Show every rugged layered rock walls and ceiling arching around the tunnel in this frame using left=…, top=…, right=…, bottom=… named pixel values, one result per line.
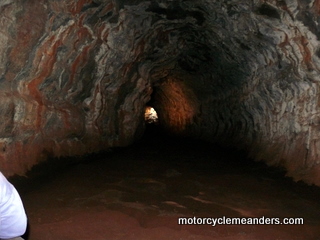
left=0, top=0, right=320, bottom=185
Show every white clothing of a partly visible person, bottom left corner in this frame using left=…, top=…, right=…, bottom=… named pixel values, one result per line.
left=0, top=172, right=27, bottom=239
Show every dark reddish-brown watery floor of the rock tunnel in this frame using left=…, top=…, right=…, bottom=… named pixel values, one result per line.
left=11, top=129, right=320, bottom=240
